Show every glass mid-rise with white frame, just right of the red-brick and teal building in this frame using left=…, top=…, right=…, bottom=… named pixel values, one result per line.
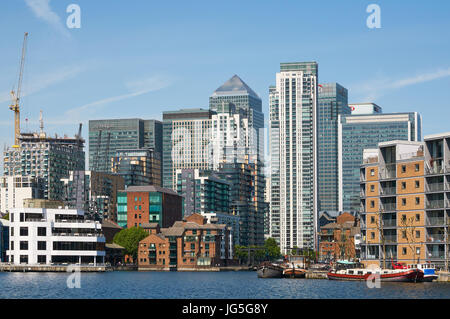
left=176, top=169, right=230, bottom=216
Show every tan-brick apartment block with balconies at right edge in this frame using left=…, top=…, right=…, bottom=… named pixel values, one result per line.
left=361, top=133, right=450, bottom=267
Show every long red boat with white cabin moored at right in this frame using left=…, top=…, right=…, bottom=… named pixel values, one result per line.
left=327, top=268, right=423, bottom=282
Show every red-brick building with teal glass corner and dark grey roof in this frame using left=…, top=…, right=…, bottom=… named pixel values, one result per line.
left=117, top=185, right=183, bottom=228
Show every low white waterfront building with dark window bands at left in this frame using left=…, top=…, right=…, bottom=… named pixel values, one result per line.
left=7, top=208, right=105, bottom=265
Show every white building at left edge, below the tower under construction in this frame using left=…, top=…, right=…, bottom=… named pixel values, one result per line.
left=0, top=175, right=43, bottom=213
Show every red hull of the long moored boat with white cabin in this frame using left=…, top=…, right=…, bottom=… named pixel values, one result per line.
left=327, top=269, right=424, bottom=282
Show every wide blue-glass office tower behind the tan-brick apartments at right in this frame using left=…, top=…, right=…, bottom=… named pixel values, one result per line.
left=338, top=112, right=422, bottom=211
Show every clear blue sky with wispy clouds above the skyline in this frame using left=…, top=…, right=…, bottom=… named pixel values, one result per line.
left=0, top=0, right=450, bottom=155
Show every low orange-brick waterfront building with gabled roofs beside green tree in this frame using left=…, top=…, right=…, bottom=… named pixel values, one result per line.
left=138, top=214, right=233, bottom=271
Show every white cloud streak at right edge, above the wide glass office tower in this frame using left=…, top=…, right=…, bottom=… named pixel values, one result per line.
left=349, top=68, right=450, bottom=101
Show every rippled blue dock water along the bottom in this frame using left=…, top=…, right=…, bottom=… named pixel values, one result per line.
left=0, top=271, right=450, bottom=299
